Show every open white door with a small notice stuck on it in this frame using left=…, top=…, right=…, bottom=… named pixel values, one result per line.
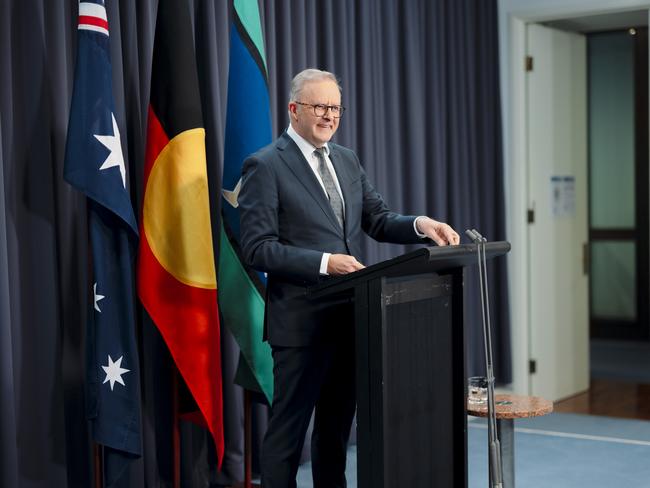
left=526, top=24, right=589, bottom=401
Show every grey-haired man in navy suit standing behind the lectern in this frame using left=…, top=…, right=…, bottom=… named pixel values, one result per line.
left=238, top=69, right=459, bottom=488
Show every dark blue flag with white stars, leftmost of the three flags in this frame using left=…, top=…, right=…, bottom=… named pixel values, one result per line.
left=64, top=0, right=142, bottom=486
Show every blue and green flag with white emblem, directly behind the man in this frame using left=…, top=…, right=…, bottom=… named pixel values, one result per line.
left=219, top=0, right=273, bottom=405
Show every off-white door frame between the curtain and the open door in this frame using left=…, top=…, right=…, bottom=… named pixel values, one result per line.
left=499, top=4, right=650, bottom=394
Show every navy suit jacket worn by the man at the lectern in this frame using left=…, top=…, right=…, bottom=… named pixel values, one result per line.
left=238, top=132, right=424, bottom=346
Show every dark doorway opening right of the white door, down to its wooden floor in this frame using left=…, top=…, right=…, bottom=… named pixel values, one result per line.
left=587, top=25, right=650, bottom=418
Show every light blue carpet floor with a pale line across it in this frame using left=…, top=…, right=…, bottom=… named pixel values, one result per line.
left=298, top=413, right=650, bottom=488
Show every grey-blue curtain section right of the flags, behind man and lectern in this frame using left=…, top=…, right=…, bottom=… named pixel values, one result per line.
left=264, top=0, right=512, bottom=383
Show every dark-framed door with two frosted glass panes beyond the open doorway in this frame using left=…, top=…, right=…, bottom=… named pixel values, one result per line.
left=587, top=25, right=650, bottom=341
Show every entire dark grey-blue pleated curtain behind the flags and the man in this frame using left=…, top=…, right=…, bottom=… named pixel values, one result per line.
left=0, top=0, right=511, bottom=487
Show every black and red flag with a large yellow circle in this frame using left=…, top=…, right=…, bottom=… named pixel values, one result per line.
left=138, top=0, right=224, bottom=465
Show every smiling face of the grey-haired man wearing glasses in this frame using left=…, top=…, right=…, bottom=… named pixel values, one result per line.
left=289, top=80, right=341, bottom=147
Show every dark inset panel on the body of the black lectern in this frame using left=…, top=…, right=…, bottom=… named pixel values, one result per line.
left=381, top=275, right=450, bottom=487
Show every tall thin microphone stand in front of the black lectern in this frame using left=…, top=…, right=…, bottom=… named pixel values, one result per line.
left=465, top=229, right=503, bottom=488
